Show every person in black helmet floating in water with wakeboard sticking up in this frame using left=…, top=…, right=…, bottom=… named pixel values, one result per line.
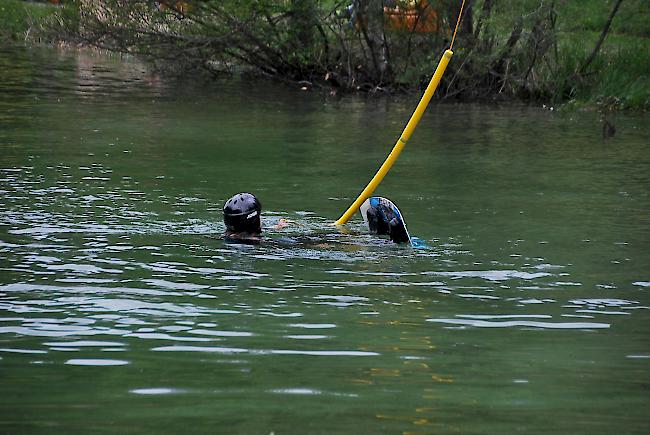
left=223, top=193, right=410, bottom=244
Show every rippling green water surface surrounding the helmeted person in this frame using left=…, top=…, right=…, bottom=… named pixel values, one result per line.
left=0, top=49, right=650, bottom=434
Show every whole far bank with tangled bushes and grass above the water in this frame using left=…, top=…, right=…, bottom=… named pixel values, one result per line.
left=0, top=0, right=650, bottom=111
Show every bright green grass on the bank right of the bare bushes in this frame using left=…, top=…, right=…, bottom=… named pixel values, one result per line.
left=473, top=0, right=650, bottom=111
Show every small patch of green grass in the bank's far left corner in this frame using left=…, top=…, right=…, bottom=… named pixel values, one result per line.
left=0, top=0, right=58, bottom=42
